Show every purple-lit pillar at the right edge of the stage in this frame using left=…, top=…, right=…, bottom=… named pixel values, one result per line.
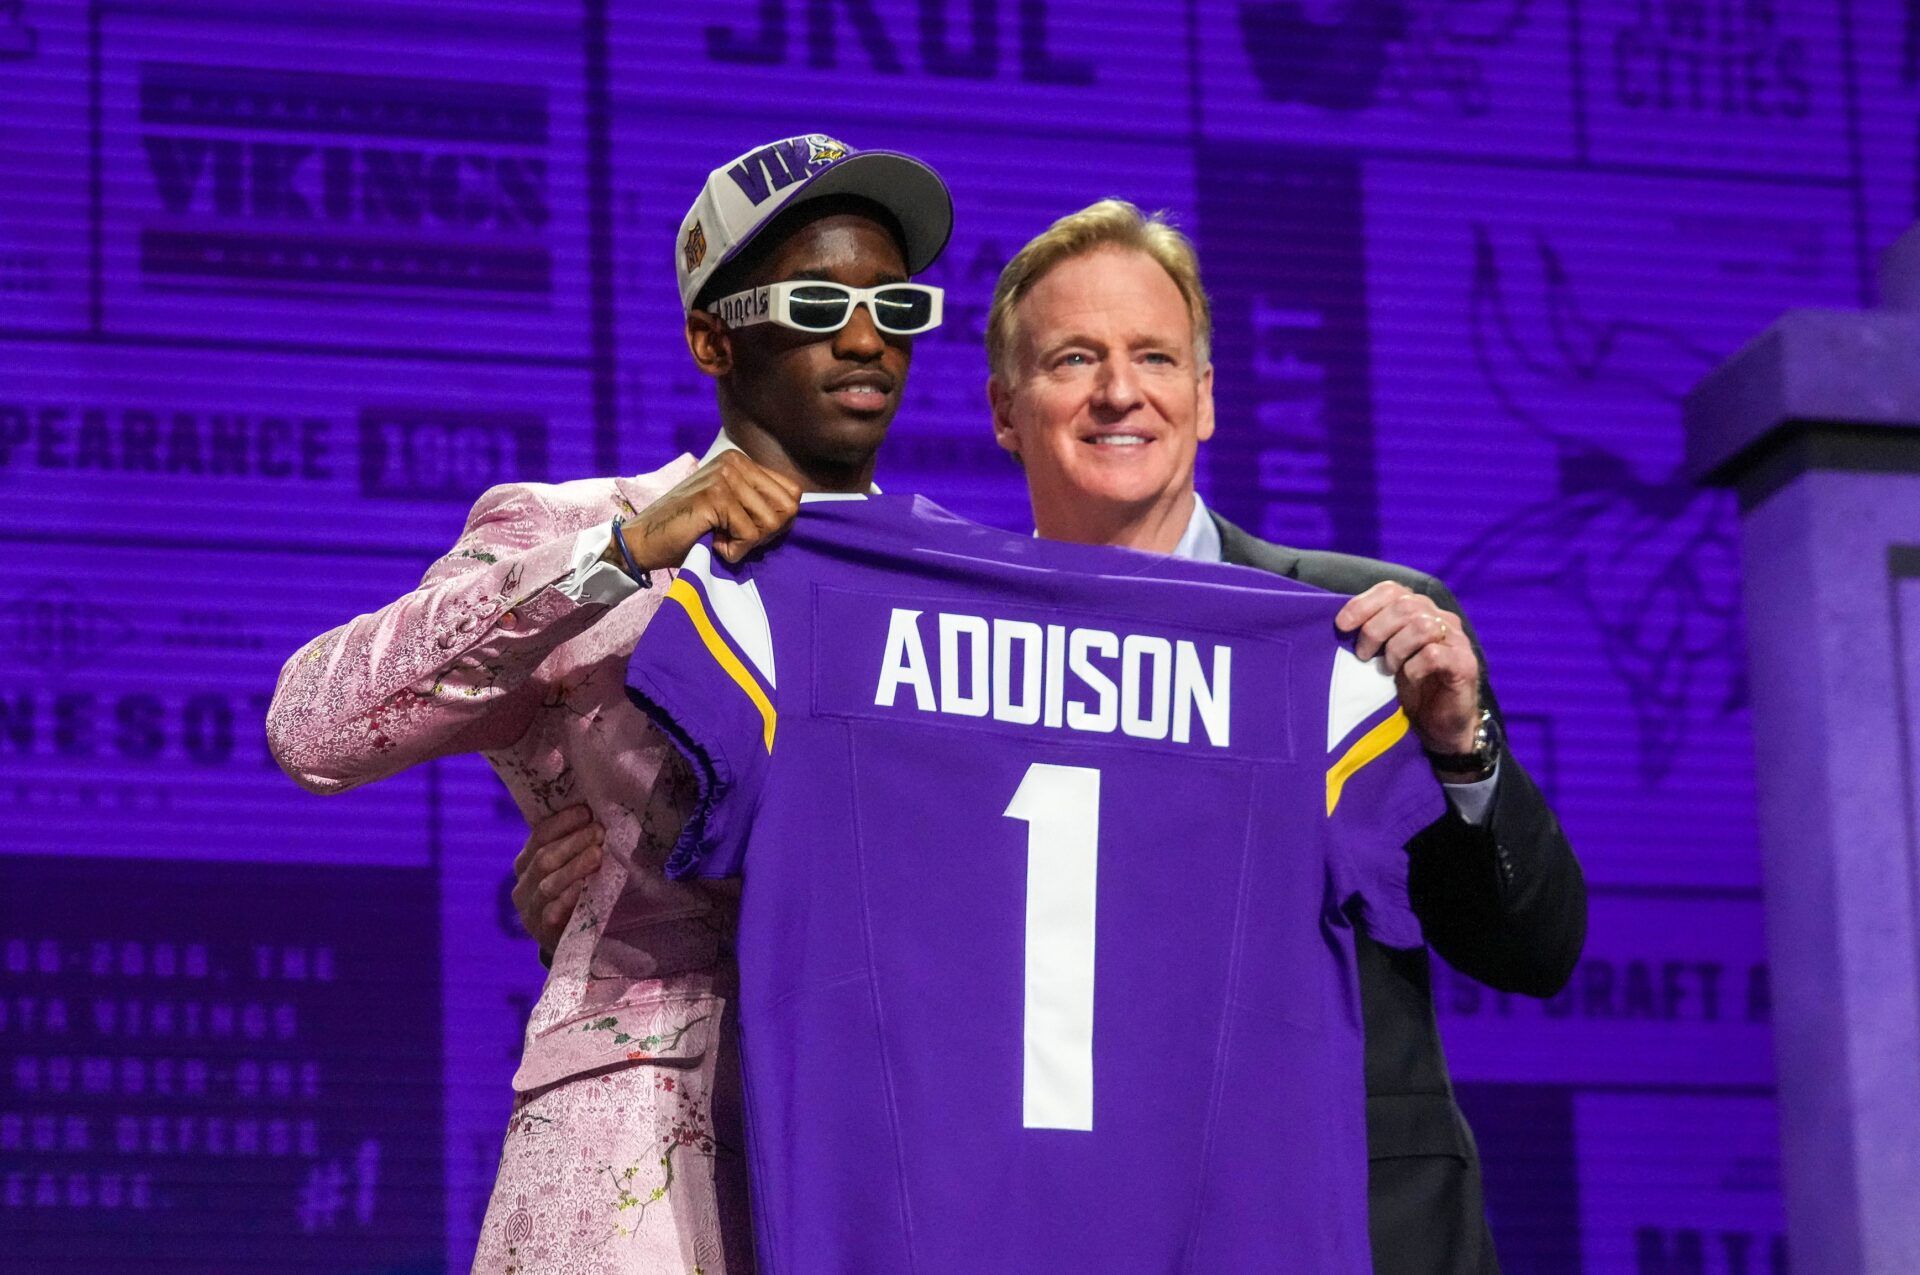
left=1686, top=225, right=1920, bottom=1275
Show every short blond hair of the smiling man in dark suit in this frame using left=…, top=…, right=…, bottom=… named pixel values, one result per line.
left=987, top=200, right=1213, bottom=384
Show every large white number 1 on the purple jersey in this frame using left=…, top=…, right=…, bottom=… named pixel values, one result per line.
left=1006, top=762, right=1100, bottom=1129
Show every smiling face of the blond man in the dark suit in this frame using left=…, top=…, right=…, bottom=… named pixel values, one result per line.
left=989, top=248, right=1213, bottom=553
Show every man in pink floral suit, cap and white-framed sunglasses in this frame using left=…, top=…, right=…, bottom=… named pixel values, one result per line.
left=267, top=134, right=952, bottom=1275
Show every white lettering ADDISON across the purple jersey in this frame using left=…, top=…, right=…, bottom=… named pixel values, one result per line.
left=874, top=607, right=1233, bottom=749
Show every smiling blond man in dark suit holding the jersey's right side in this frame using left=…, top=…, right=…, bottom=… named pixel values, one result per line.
left=516, top=200, right=1586, bottom=1275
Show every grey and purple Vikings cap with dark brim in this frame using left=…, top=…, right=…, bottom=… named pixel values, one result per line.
left=674, top=132, right=954, bottom=309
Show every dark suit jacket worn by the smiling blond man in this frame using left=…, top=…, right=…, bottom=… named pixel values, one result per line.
left=1213, top=515, right=1586, bottom=1275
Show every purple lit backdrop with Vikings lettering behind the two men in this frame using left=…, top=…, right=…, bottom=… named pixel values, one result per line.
left=0, top=0, right=1920, bottom=1275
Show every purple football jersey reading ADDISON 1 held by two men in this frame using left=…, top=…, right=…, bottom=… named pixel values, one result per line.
left=628, top=495, right=1444, bottom=1275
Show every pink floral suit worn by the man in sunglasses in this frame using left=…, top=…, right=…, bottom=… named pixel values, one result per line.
left=267, top=455, right=751, bottom=1275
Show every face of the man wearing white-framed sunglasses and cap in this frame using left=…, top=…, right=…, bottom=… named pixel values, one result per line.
left=687, top=211, right=914, bottom=492
